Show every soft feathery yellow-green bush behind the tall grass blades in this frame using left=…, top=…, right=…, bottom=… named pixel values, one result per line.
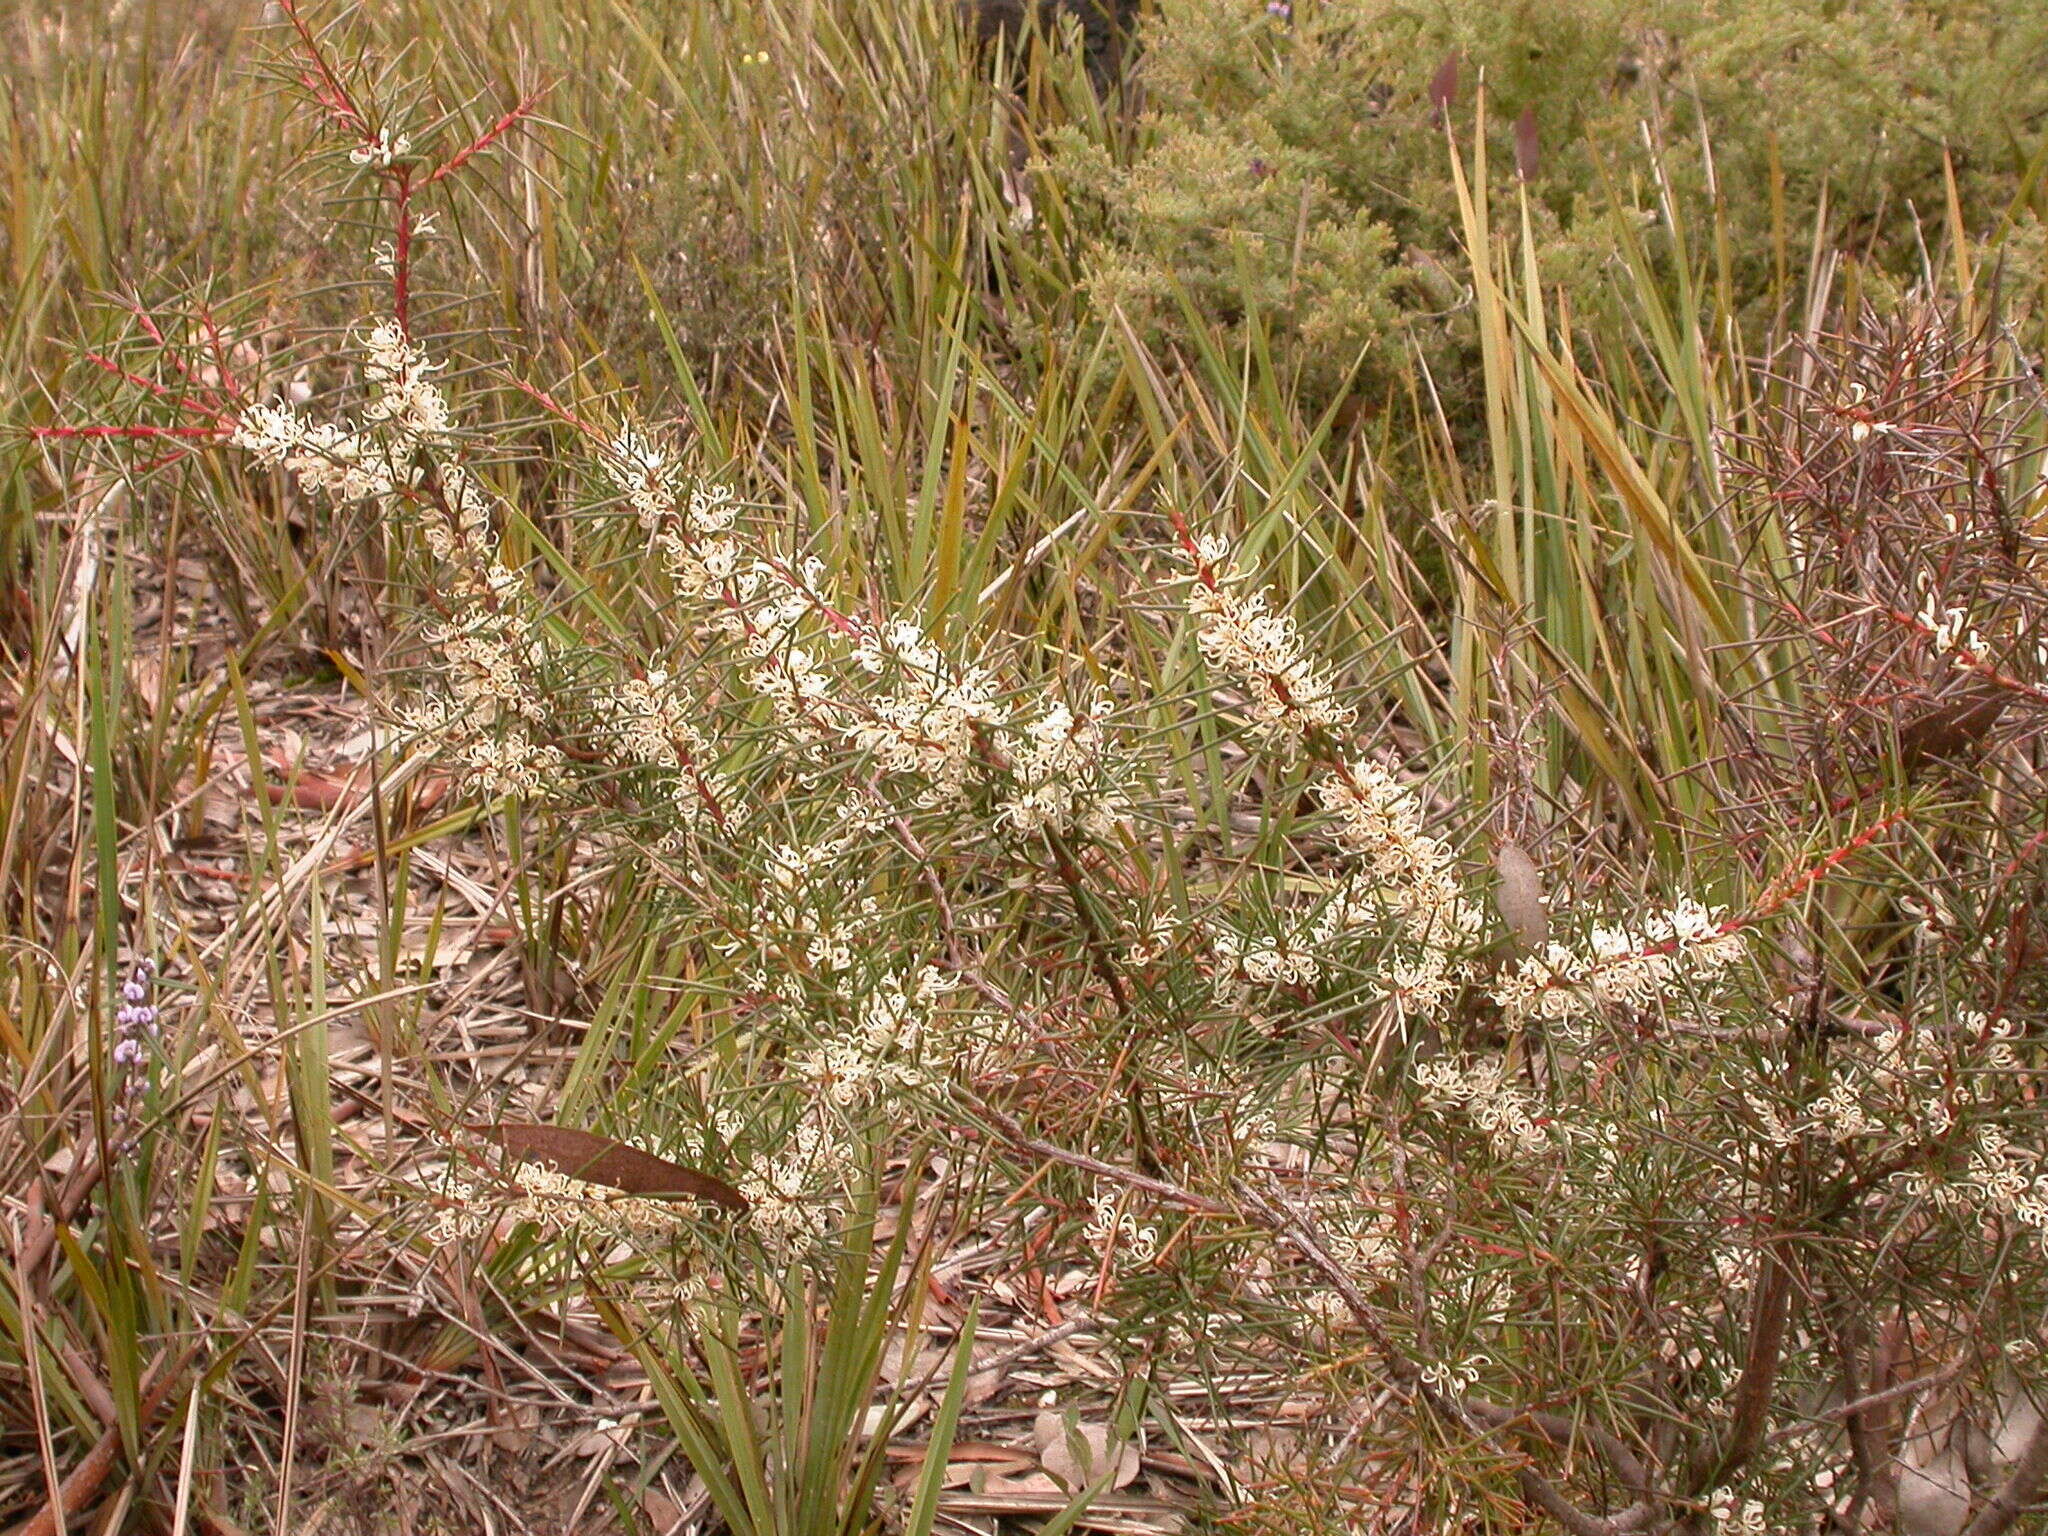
left=1049, top=0, right=2048, bottom=395
